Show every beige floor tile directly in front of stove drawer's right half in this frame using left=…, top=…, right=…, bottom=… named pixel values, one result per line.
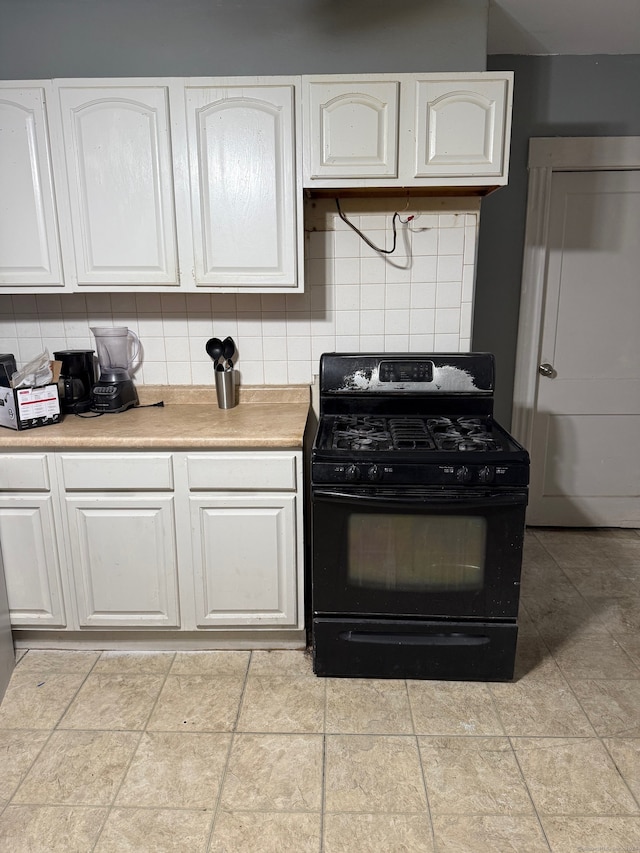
left=407, top=681, right=504, bottom=735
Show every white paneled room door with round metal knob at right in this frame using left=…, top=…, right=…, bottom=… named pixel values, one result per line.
left=516, top=162, right=640, bottom=527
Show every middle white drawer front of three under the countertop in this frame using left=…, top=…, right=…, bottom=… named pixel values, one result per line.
left=60, top=452, right=173, bottom=492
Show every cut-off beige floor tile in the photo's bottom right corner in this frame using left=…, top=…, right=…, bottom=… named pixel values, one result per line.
left=542, top=817, right=640, bottom=853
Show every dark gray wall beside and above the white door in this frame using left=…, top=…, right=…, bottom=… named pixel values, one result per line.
left=473, top=55, right=640, bottom=425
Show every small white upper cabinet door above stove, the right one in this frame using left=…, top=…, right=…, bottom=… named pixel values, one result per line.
left=410, top=79, right=510, bottom=185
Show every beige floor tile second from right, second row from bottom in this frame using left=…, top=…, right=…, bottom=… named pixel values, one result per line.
left=512, top=738, right=639, bottom=815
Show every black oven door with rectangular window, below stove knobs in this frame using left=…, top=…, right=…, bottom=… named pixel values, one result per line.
left=312, top=487, right=527, bottom=620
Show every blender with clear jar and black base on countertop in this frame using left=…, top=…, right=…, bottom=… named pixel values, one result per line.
left=91, top=326, right=140, bottom=413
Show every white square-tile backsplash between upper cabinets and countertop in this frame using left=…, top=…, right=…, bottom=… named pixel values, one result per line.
left=0, top=198, right=480, bottom=384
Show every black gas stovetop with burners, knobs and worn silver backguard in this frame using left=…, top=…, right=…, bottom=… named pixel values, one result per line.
left=311, top=353, right=529, bottom=486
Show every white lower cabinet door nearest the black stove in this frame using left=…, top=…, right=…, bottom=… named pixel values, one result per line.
left=190, top=494, right=297, bottom=628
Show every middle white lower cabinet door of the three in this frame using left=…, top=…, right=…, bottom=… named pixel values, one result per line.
left=65, top=494, right=179, bottom=628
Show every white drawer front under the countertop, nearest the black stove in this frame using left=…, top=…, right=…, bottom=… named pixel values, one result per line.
left=187, top=452, right=296, bottom=491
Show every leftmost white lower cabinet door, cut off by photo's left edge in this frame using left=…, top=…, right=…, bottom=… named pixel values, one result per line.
left=0, top=493, right=66, bottom=628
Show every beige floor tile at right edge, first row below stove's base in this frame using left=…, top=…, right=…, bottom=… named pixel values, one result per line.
left=573, top=679, right=640, bottom=737
